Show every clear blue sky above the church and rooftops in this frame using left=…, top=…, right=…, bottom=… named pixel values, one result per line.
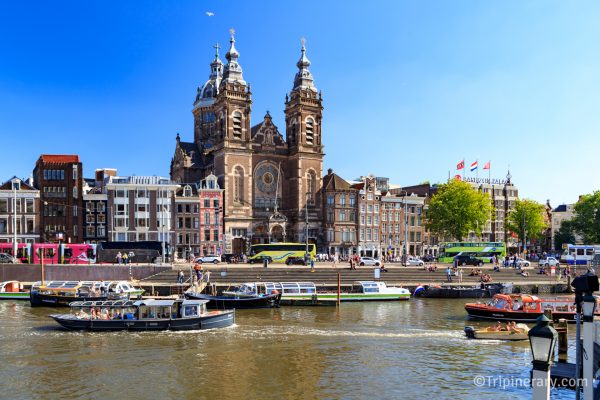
left=0, top=0, right=600, bottom=205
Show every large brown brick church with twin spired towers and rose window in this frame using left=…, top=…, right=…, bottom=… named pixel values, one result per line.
left=171, top=30, right=324, bottom=253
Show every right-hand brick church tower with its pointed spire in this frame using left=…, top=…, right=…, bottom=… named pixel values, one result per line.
left=285, top=39, right=323, bottom=243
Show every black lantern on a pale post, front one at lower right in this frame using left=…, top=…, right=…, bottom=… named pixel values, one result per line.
left=528, top=315, right=558, bottom=400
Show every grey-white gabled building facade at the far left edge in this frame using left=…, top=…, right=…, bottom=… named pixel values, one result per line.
left=0, top=177, right=40, bottom=243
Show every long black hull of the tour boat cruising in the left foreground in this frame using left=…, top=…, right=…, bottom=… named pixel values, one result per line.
left=50, top=310, right=235, bottom=332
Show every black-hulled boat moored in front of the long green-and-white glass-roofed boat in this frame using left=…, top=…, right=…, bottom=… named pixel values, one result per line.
left=185, top=283, right=281, bottom=309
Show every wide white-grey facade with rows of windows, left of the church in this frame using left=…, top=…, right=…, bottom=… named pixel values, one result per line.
left=104, top=176, right=179, bottom=247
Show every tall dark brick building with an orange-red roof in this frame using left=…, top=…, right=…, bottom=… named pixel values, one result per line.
left=33, top=154, right=83, bottom=243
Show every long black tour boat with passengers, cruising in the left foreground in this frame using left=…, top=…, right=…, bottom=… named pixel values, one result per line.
left=50, top=299, right=235, bottom=331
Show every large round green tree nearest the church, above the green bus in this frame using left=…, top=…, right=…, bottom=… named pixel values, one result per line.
left=425, top=181, right=493, bottom=241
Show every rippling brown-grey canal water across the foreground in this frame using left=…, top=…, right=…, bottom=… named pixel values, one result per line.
left=0, top=299, right=574, bottom=399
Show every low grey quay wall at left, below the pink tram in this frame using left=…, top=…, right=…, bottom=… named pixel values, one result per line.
left=0, top=264, right=171, bottom=283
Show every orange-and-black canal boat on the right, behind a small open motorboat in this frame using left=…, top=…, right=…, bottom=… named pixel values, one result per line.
left=465, top=294, right=600, bottom=322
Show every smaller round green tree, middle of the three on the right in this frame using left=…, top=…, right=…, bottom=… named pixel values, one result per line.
left=506, top=199, right=548, bottom=252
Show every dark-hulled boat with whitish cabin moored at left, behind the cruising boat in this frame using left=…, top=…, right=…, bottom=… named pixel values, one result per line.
left=29, top=281, right=108, bottom=307
